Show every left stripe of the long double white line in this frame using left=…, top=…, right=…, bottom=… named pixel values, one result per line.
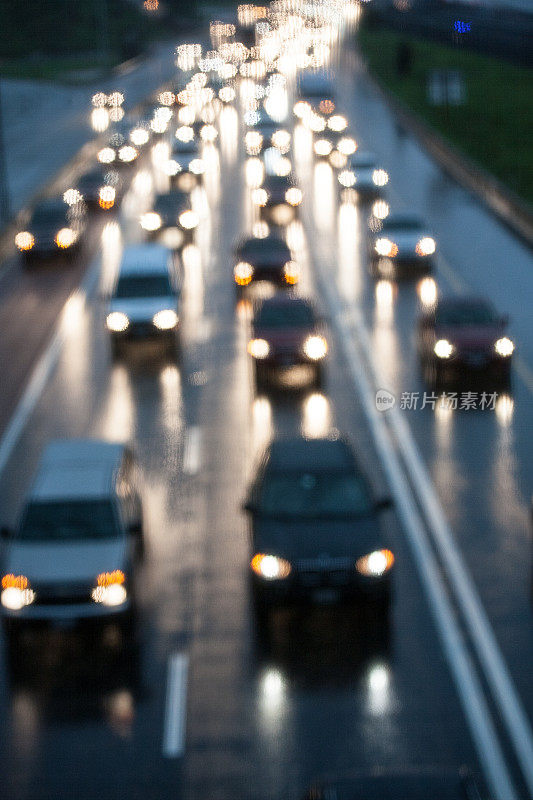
left=310, top=268, right=518, bottom=800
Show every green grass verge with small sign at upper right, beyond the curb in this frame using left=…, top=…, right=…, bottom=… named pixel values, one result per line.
left=358, top=25, right=533, bottom=209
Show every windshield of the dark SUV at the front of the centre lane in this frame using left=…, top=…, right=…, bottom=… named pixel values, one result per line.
left=259, top=472, right=371, bottom=519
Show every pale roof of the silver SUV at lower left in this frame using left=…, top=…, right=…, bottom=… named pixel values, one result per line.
left=30, top=439, right=124, bottom=502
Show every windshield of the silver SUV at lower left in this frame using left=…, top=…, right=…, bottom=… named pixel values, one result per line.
left=19, top=500, right=120, bottom=542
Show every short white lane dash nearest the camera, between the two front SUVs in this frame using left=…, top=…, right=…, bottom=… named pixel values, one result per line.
left=163, top=653, right=189, bottom=758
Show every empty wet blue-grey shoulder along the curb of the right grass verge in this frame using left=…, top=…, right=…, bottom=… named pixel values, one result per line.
left=338, top=42, right=533, bottom=369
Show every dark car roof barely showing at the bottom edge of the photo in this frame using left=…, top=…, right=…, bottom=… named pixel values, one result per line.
left=304, top=768, right=488, bottom=800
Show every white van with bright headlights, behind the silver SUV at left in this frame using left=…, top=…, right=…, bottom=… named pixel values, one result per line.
left=106, top=243, right=181, bottom=354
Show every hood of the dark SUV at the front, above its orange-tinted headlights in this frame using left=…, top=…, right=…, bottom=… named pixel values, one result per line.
left=254, top=517, right=383, bottom=562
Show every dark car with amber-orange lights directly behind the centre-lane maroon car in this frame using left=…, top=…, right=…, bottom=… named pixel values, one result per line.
left=233, top=234, right=300, bottom=295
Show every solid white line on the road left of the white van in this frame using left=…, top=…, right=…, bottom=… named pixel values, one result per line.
left=0, top=259, right=98, bottom=474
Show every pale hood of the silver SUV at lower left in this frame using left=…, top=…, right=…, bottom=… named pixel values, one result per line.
left=4, top=537, right=128, bottom=585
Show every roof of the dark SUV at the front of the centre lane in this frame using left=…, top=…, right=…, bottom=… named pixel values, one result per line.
left=268, top=436, right=356, bottom=472
